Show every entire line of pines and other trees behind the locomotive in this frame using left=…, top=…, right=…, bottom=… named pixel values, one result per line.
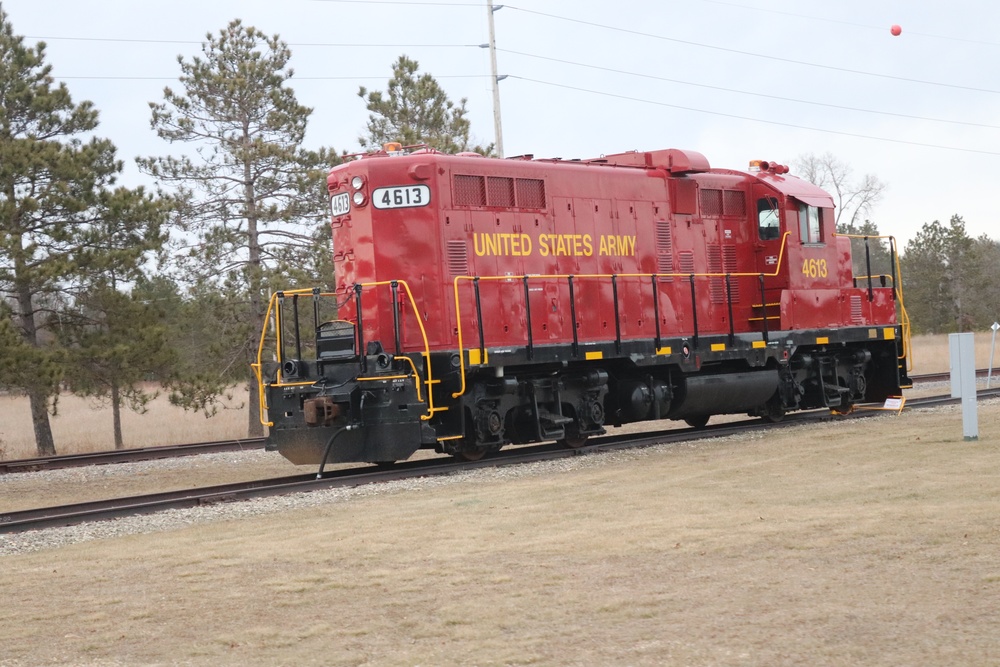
left=0, top=8, right=998, bottom=456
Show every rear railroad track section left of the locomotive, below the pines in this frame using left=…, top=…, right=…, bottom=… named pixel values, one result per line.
left=0, top=438, right=264, bottom=475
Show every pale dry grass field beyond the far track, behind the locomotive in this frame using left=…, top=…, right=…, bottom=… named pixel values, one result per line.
left=0, top=332, right=1000, bottom=459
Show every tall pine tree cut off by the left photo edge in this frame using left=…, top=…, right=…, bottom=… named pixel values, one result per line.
left=0, top=9, right=137, bottom=456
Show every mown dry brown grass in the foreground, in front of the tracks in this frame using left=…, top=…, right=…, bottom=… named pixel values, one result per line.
left=0, top=402, right=1000, bottom=666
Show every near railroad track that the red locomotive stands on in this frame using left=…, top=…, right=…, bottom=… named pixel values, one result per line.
left=0, top=388, right=1000, bottom=534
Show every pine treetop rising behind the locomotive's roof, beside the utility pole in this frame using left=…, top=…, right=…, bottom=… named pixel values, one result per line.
left=358, top=55, right=493, bottom=155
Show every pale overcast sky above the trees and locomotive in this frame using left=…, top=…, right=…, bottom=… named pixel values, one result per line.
left=0, top=0, right=1000, bottom=244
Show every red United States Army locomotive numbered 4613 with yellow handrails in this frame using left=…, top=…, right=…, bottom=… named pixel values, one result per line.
left=255, top=146, right=909, bottom=466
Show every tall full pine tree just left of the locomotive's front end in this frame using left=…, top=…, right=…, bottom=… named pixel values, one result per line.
left=139, top=20, right=338, bottom=435
